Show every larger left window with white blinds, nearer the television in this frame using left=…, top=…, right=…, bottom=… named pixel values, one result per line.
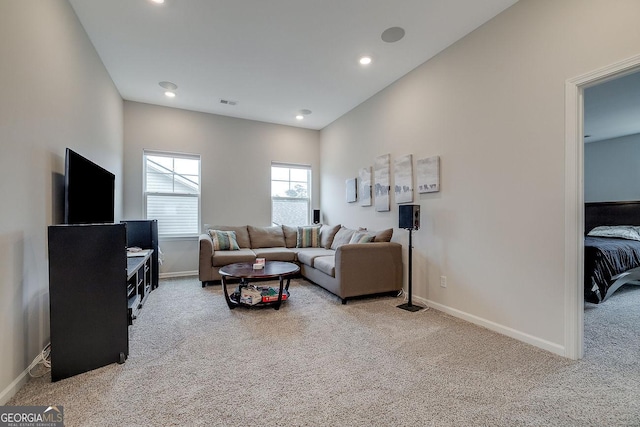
left=144, top=151, right=200, bottom=237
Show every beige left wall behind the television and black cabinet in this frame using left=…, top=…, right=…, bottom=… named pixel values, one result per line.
left=0, top=0, right=123, bottom=404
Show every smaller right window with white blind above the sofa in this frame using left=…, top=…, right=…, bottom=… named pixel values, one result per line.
left=271, top=162, right=311, bottom=226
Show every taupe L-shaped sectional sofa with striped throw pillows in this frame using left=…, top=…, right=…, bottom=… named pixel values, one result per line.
left=199, top=224, right=403, bottom=304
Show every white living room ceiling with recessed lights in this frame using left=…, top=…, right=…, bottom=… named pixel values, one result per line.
left=70, top=0, right=516, bottom=129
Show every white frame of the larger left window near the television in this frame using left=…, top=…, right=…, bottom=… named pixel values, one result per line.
left=142, top=149, right=202, bottom=240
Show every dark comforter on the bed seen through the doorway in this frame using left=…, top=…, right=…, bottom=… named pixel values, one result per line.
left=584, top=236, right=640, bottom=304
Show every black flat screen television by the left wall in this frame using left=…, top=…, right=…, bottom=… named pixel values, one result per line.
left=64, top=148, right=116, bottom=224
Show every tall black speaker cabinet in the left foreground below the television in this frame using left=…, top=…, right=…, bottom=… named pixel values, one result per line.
left=49, top=224, right=129, bottom=381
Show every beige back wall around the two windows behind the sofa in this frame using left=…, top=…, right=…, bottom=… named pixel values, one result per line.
left=124, top=101, right=320, bottom=274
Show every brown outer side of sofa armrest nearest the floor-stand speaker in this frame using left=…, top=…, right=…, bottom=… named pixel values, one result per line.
left=335, top=242, right=403, bottom=298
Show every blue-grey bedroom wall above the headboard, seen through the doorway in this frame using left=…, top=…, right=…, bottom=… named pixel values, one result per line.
left=584, top=134, right=640, bottom=202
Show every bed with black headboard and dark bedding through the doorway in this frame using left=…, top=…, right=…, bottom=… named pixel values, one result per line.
left=584, top=201, right=640, bottom=304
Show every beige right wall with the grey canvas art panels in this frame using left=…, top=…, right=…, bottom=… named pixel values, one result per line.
left=321, top=0, right=640, bottom=354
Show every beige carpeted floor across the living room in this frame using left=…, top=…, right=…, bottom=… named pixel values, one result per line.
left=8, top=278, right=640, bottom=427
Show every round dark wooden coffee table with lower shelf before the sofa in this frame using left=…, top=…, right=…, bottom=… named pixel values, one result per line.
left=219, top=261, right=300, bottom=310
